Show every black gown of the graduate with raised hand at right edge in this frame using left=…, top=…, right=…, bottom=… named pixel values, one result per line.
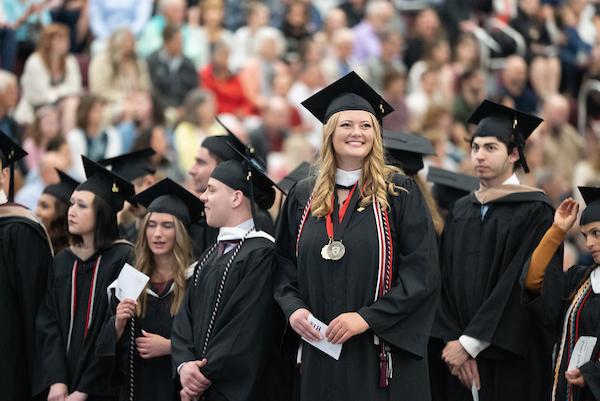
left=523, top=263, right=600, bottom=401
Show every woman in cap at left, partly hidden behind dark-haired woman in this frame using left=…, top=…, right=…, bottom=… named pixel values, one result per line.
left=35, top=169, right=80, bottom=254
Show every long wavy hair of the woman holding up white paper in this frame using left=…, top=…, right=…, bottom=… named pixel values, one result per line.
left=135, top=212, right=192, bottom=316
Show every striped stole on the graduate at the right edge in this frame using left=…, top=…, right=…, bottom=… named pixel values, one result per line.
left=552, top=277, right=592, bottom=401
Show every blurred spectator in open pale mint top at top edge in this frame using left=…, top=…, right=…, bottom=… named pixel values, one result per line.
left=137, top=0, right=209, bottom=68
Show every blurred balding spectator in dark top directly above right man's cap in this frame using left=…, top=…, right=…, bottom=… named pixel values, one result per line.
left=499, top=55, right=537, bottom=114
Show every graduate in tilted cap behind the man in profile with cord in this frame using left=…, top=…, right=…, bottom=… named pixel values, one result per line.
left=188, top=126, right=275, bottom=258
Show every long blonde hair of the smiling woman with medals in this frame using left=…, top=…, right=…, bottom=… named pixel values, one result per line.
left=311, top=112, right=400, bottom=217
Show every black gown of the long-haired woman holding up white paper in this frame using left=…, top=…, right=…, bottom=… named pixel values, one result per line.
left=97, top=287, right=179, bottom=401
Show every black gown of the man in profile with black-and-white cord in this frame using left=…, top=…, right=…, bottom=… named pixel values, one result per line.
left=171, top=238, right=286, bottom=401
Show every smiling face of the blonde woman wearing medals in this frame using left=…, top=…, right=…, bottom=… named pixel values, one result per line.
left=332, top=110, right=375, bottom=170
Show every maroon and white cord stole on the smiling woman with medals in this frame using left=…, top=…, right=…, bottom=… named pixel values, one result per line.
left=296, top=194, right=393, bottom=388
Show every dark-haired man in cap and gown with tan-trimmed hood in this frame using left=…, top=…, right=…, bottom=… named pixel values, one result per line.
left=432, top=100, right=561, bottom=401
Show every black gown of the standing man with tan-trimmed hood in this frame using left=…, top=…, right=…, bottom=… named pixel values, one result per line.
left=432, top=192, right=562, bottom=401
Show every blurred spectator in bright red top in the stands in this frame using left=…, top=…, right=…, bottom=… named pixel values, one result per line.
left=200, top=42, right=255, bottom=120
